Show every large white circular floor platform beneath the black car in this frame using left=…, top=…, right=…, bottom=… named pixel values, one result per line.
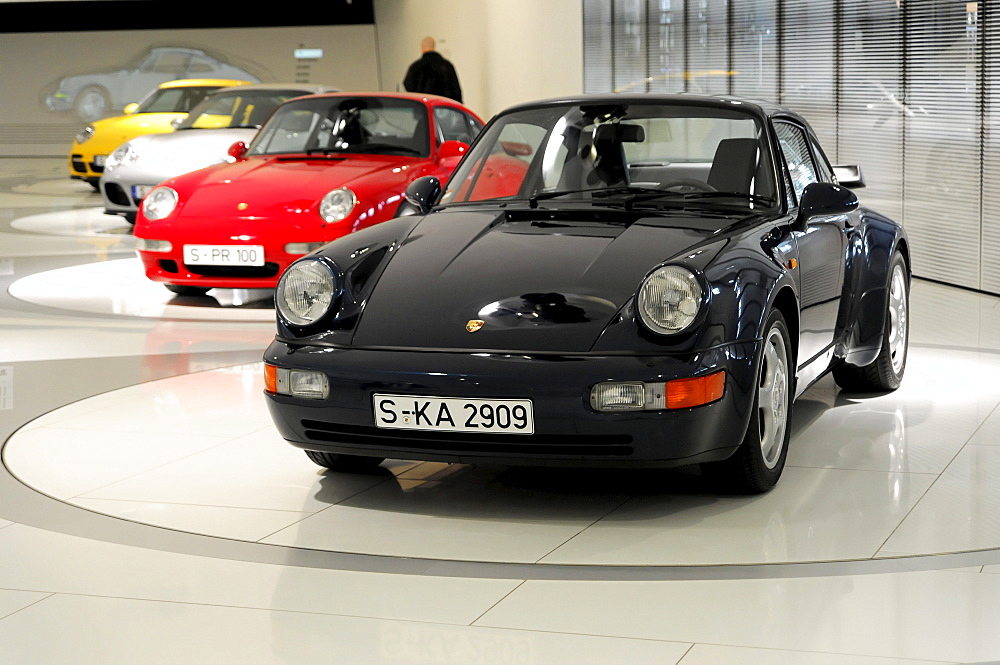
left=4, top=345, right=1000, bottom=566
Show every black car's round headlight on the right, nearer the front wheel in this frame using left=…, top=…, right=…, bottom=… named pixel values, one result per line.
left=638, top=266, right=703, bottom=335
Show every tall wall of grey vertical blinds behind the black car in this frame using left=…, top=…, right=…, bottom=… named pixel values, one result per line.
left=583, top=0, right=1000, bottom=293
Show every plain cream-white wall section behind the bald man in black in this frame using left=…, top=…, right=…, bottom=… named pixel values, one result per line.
left=374, top=0, right=583, bottom=119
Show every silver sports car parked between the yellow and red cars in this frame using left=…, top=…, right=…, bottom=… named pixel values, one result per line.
left=100, top=83, right=336, bottom=224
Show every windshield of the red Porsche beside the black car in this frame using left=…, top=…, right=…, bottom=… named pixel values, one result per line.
left=249, top=97, right=430, bottom=157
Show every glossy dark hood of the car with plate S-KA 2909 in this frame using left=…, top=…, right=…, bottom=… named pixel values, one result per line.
left=353, top=210, right=739, bottom=353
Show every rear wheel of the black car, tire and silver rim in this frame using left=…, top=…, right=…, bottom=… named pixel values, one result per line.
left=833, top=252, right=910, bottom=392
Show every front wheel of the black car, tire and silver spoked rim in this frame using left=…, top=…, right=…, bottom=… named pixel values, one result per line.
left=721, top=310, right=795, bottom=494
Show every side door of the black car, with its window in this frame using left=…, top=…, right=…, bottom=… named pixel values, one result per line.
left=774, top=120, right=848, bottom=371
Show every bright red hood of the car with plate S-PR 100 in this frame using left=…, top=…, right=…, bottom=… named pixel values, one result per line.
left=178, top=156, right=407, bottom=220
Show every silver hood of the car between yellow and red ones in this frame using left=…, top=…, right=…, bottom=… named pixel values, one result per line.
left=125, top=129, right=257, bottom=182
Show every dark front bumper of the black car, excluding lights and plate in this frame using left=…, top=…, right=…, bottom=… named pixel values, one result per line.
left=264, top=341, right=760, bottom=467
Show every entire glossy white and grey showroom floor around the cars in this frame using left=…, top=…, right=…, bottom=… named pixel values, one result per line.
left=0, top=159, right=1000, bottom=665
